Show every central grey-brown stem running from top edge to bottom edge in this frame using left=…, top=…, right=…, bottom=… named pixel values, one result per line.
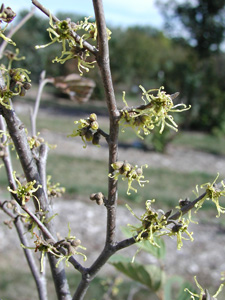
left=73, top=0, right=120, bottom=300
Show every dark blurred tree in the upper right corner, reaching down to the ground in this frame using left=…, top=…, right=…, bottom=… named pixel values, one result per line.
left=158, top=0, right=225, bottom=132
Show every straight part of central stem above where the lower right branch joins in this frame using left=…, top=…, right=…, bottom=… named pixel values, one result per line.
left=93, top=0, right=119, bottom=245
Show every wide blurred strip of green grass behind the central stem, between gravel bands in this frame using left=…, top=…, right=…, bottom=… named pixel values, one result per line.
left=44, top=154, right=214, bottom=207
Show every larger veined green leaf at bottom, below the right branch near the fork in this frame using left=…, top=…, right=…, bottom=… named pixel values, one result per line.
left=109, top=255, right=165, bottom=291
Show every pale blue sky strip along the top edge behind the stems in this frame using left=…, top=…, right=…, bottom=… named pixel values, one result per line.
left=5, top=0, right=163, bottom=29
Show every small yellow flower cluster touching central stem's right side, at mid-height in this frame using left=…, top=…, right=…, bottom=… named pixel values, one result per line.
left=109, top=161, right=149, bottom=195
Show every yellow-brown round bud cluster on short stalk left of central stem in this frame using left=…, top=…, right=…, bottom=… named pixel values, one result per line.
left=68, top=113, right=101, bottom=148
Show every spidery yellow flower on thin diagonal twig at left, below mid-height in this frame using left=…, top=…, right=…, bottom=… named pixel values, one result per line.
left=8, top=172, right=42, bottom=210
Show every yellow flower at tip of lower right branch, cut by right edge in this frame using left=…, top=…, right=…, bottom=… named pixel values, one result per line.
left=194, top=173, right=225, bottom=218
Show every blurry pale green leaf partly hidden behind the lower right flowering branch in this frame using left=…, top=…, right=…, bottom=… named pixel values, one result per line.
left=121, top=226, right=166, bottom=259
